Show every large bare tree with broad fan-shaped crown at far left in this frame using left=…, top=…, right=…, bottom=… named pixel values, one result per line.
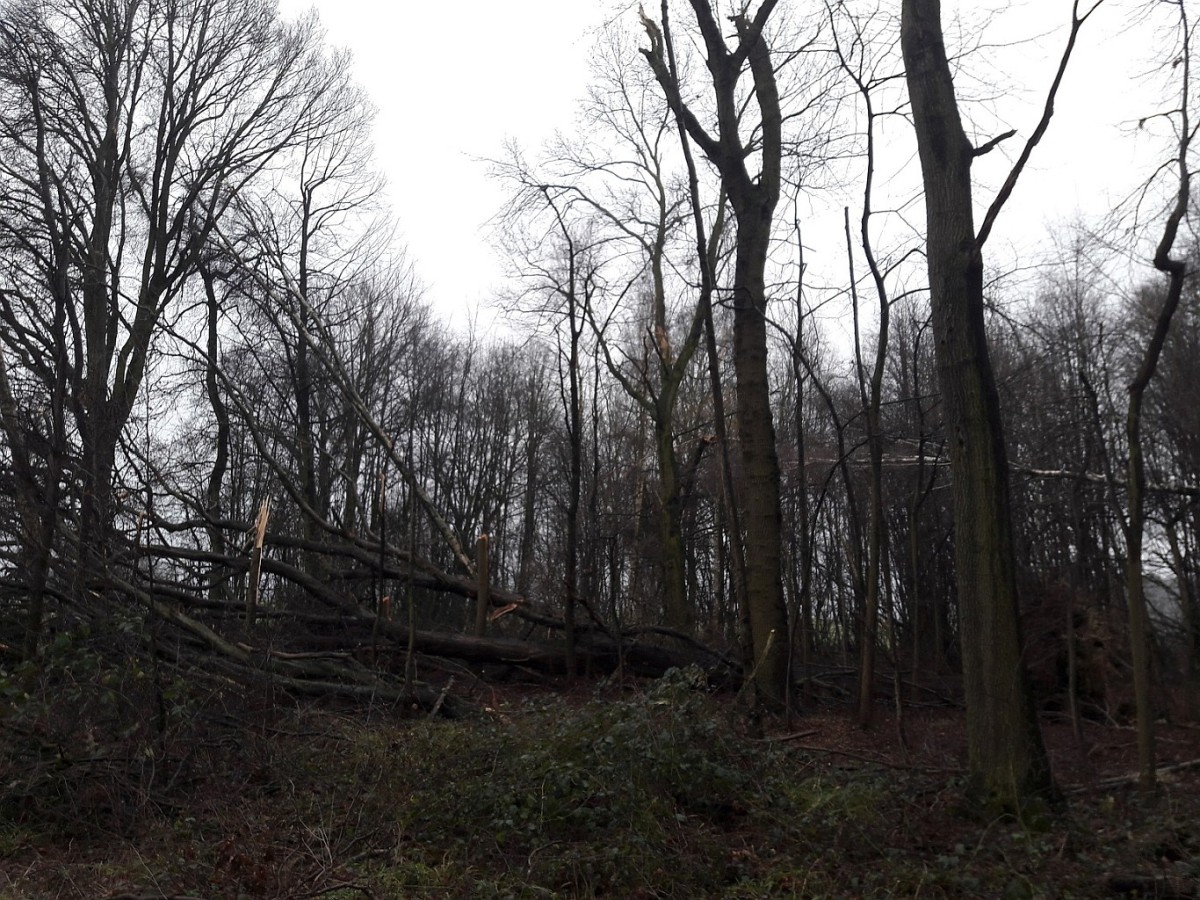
left=0, top=0, right=343, bottom=648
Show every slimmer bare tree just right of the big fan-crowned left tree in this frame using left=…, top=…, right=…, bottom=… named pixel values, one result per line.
left=221, top=66, right=388, bottom=578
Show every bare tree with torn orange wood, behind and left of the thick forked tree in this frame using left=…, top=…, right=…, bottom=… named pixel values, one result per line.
left=535, top=30, right=721, bottom=632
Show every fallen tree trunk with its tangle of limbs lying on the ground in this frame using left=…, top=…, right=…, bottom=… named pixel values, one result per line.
left=44, top=513, right=740, bottom=712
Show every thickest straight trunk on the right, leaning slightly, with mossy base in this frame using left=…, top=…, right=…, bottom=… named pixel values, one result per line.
left=901, top=0, right=1054, bottom=809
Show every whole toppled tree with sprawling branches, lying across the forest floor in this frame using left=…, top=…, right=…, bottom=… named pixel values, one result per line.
left=23, top=521, right=740, bottom=715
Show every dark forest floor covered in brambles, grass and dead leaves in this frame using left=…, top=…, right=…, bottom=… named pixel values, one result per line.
left=0, top=673, right=1200, bottom=900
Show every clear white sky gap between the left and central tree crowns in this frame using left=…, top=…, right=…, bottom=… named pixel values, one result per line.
left=273, top=0, right=609, bottom=325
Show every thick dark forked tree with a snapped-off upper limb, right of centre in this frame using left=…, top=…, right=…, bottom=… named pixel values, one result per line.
left=642, top=0, right=790, bottom=706
